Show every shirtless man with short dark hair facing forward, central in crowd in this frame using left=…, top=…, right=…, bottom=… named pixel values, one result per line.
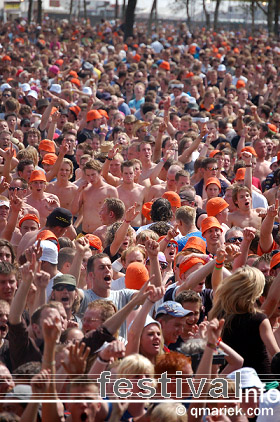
left=117, top=161, right=145, bottom=227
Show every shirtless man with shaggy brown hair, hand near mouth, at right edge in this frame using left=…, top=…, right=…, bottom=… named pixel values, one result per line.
left=228, top=186, right=262, bottom=230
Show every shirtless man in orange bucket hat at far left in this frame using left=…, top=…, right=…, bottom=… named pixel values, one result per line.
left=26, top=170, right=60, bottom=226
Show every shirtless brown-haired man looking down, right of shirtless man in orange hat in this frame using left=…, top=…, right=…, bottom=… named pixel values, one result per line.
left=71, top=160, right=118, bottom=234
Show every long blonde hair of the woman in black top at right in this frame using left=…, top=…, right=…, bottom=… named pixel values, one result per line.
left=209, top=265, right=265, bottom=320
